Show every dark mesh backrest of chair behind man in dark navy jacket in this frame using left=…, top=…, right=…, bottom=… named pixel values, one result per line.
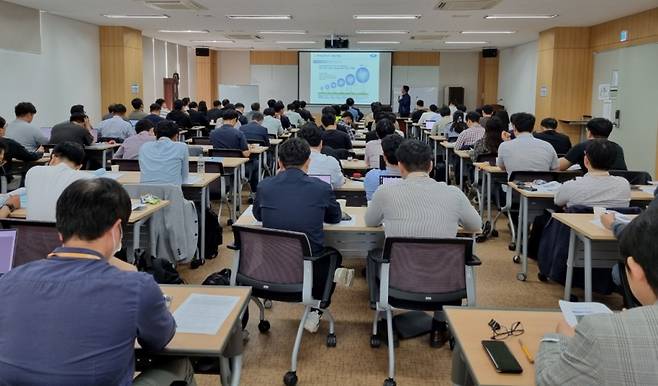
left=238, top=232, right=304, bottom=284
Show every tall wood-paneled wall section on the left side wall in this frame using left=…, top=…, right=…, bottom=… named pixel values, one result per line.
left=99, top=26, right=144, bottom=112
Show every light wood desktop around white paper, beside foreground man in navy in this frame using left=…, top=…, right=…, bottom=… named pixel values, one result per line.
left=138, top=285, right=251, bottom=356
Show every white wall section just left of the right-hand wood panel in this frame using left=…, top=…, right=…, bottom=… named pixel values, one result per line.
left=498, top=41, right=546, bottom=114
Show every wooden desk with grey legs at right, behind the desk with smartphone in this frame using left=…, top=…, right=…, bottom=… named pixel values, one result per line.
left=553, top=213, right=637, bottom=302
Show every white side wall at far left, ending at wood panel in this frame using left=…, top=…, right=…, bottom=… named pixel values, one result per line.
left=0, top=13, right=101, bottom=127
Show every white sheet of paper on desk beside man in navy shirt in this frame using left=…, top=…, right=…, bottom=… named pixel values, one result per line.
left=174, top=294, right=240, bottom=335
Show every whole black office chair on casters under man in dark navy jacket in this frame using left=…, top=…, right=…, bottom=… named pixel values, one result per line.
left=229, top=225, right=337, bottom=386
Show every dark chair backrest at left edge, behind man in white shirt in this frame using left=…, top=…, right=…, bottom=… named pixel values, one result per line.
left=2, top=219, right=62, bottom=267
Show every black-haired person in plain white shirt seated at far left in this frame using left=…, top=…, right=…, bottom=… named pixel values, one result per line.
left=25, top=142, right=92, bottom=222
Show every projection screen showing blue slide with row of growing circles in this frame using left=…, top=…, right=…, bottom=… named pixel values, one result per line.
left=299, top=51, right=391, bottom=105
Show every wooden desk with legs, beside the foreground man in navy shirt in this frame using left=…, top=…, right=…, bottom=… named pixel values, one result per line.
left=142, top=285, right=251, bottom=386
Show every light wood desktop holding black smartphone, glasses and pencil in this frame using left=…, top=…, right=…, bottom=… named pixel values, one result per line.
left=444, top=306, right=562, bottom=386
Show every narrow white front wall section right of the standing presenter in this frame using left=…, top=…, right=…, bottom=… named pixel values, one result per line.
left=439, top=52, right=480, bottom=110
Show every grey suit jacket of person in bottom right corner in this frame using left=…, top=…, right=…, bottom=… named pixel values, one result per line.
left=535, top=304, right=658, bottom=386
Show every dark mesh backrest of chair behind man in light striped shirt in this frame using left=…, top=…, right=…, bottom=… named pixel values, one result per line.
left=390, top=243, right=466, bottom=294
